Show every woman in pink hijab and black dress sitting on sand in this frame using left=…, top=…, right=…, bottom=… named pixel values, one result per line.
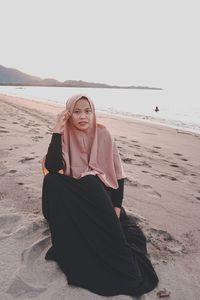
left=42, top=95, right=158, bottom=296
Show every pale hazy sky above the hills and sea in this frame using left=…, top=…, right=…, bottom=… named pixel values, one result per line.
left=0, top=0, right=200, bottom=89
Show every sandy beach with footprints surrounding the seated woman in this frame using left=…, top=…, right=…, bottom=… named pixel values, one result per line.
left=0, top=94, right=200, bottom=300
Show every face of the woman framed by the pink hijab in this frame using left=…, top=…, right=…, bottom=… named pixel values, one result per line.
left=71, top=99, right=94, bottom=130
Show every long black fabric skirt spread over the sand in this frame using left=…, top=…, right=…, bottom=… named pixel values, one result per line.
left=42, top=173, right=158, bottom=296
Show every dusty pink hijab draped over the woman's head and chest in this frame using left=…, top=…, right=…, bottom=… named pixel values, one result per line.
left=62, top=94, right=126, bottom=189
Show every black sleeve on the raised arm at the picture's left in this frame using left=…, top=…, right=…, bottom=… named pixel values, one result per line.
left=45, top=133, right=63, bottom=173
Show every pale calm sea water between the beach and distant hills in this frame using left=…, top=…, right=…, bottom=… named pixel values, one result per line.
left=0, top=86, right=200, bottom=133
